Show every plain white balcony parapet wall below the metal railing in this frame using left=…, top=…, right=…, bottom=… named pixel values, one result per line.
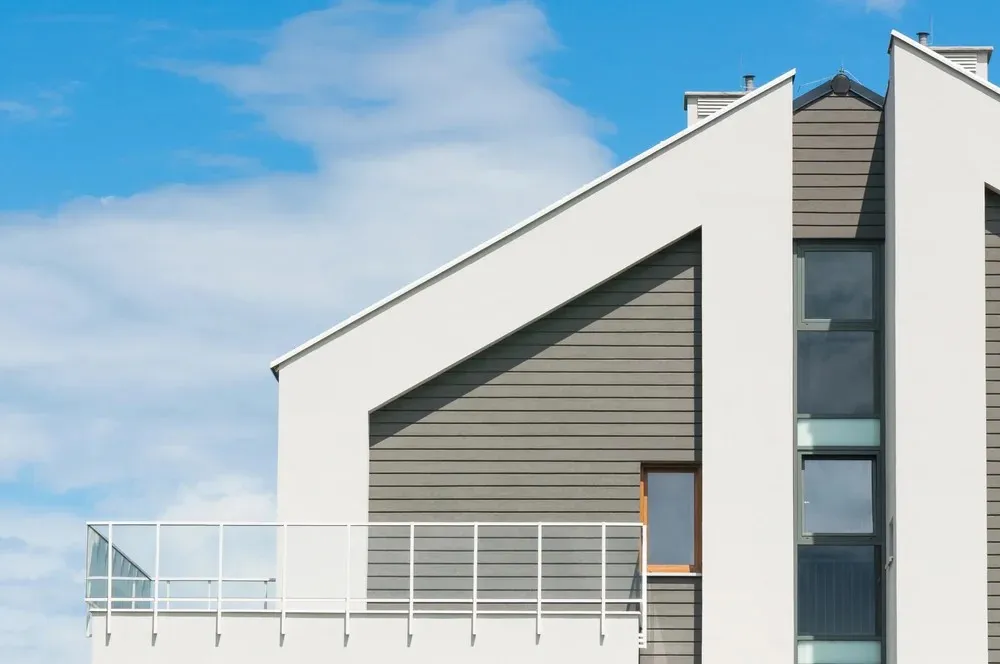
left=90, top=614, right=639, bottom=664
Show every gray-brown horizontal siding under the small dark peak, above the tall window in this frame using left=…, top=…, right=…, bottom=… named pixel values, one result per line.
left=792, top=95, right=885, bottom=239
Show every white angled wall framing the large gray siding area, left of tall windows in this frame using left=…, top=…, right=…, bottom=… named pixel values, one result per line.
left=278, top=72, right=794, bottom=664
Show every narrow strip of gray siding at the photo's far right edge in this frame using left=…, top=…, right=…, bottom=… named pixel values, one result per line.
left=986, top=190, right=1000, bottom=662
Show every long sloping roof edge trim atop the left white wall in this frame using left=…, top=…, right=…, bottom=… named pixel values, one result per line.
left=270, top=69, right=796, bottom=378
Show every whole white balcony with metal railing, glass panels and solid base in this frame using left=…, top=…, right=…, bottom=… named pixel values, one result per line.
left=86, top=522, right=647, bottom=664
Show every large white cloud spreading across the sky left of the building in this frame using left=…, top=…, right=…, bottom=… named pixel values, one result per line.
left=0, top=3, right=611, bottom=664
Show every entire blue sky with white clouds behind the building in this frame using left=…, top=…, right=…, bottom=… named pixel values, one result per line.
left=0, top=0, right=1000, bottom=664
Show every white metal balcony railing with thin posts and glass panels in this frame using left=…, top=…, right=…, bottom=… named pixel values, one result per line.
left=85, top=521, right=648, bottom=647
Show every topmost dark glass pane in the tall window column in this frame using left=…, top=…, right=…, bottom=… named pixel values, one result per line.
left=803, top=251, right=875, bottom=320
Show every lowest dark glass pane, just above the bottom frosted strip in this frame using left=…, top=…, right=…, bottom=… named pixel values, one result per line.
left=798, top=545, right=878, bottom=638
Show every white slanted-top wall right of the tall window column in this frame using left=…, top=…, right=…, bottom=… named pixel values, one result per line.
left=886, top=36, right=1000, bottom=663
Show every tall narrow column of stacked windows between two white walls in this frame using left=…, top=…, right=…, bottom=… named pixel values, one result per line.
left=795, top=243, right=883, bottom=664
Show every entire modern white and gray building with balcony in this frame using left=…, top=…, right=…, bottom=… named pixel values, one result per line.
left=88, top=32, right=1000, bottom=664
